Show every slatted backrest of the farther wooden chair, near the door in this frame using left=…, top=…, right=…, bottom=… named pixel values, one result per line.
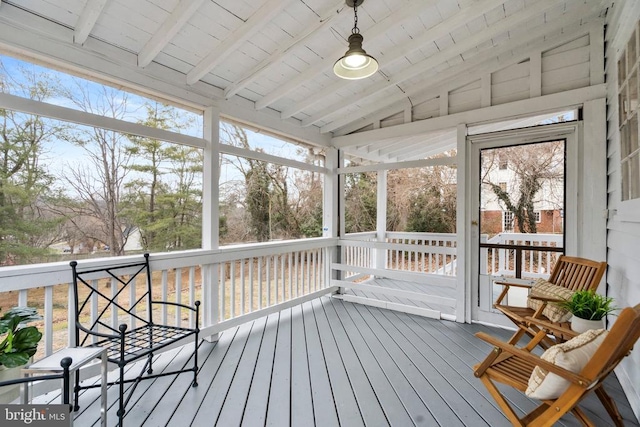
left=549, top=255, right=607, bottom=291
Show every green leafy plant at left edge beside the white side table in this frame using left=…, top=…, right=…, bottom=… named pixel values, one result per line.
left=0, top=307, right=42, bottom=368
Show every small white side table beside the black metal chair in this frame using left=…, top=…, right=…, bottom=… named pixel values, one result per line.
left=22, top=347, right=108, bottom=427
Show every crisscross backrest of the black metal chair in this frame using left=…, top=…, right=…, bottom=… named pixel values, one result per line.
left=70, top=254, right=153, bottom=346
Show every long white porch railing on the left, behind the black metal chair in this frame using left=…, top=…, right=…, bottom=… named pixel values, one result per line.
left=0, top=238, right=337, bottom=358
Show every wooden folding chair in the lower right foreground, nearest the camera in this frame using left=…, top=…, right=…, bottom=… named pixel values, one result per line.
left=474, top=304, right=640, bottom=426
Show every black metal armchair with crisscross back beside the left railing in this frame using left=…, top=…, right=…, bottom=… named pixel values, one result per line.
left=71, top=254, right=200, bottom=426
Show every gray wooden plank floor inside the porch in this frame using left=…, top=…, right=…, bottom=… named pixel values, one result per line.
left=48, top=297, right=639, bottom=427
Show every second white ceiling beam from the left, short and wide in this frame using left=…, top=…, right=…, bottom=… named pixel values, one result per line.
left=138, top=0, right=204, bottom=67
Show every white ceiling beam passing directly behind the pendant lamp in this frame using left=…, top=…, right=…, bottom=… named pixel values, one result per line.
left=256, top=0, right=438, bottom=109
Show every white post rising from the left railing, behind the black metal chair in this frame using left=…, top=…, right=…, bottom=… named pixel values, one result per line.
left=201, top=107, right=220, bottom=341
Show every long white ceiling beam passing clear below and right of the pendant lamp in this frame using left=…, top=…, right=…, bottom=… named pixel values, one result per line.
left=302, top=0, right=568, bottom=126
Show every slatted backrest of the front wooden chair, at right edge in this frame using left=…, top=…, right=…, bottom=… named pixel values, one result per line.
left=581, top=304, right=640, bottom=380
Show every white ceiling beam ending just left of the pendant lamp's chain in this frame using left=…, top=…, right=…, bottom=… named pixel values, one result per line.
left=224, top=0, right=346, bottom=99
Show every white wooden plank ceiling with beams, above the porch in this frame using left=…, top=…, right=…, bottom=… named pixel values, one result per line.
left=0, top=0, right=612, bottom=161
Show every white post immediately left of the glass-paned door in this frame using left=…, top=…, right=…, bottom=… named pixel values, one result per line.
left=456, top=124, right=470, bottom=323
